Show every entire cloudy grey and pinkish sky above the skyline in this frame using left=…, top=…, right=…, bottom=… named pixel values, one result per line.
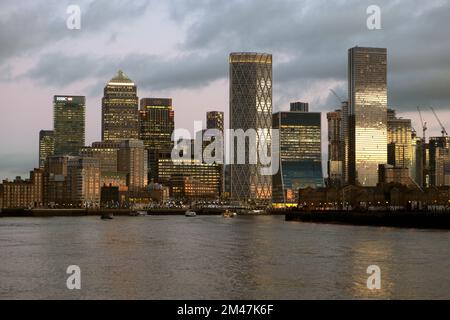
left=0, top=0, right=450, bottom=179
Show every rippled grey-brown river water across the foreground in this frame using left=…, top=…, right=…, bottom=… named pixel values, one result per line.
left=0, top=216, right=450, bottom=299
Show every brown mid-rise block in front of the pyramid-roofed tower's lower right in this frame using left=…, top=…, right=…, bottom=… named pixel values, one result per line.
left=117, top=140, right=147, bottom=191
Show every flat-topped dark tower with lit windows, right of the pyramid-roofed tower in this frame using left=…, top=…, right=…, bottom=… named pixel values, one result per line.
left=139, top=98, right=175, bottom=182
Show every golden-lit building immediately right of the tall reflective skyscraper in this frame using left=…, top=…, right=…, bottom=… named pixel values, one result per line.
left=387, top=109, right=412, bottom=168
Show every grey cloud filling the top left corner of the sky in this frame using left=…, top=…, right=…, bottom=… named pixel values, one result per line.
left=0, top=0, right=151, bottom=63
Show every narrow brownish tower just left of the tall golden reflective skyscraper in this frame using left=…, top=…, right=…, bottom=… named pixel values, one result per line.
left=327, top=110, right=344, bottom=187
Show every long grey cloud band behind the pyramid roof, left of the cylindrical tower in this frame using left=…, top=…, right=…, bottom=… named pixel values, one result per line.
left=22, top=53, right=227, bottom=94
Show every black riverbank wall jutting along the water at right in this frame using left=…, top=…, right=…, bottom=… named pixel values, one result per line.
left=286, top=211, right=450, bottom=230
